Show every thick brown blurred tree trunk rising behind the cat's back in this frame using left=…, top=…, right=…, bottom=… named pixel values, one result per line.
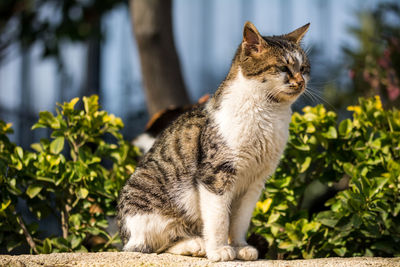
left=130, top=0, right=189, bottom=116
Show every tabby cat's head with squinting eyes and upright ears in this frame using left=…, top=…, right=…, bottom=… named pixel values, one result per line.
left=235, top=22, right=310, bottom=102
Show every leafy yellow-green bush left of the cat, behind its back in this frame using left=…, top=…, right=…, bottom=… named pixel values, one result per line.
left=0, top=96, right=137, bottom=253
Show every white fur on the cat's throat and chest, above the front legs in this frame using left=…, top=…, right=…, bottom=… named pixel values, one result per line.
left=214, top=69, right=291, bottom=180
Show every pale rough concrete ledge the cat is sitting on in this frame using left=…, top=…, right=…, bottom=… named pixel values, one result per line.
left=0, top=252, right=400, bottom=267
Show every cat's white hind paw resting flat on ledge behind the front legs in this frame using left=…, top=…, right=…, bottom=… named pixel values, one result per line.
left=166, top=237, right=206, bottom=257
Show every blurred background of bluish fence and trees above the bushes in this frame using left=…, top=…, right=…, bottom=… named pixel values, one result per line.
left=0, top=0, right=400, bottom=148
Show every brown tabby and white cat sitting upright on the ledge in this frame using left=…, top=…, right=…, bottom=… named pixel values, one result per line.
left=117, top=22, right=310, bottom=261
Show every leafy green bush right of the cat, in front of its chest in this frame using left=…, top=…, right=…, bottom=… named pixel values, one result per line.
left=252, top=97, right=400, bottom=258
